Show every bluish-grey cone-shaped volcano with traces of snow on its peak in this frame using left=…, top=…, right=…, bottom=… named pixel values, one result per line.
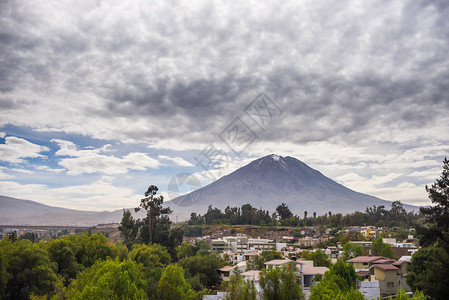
left=168, top=154, right=418, bottom=215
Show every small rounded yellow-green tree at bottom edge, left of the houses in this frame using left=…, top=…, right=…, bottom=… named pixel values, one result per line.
left=157, top=265, right=197, bottom=300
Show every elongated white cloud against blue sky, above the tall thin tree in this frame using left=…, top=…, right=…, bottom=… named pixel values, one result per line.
left=52, top=139, right=159, bottom=175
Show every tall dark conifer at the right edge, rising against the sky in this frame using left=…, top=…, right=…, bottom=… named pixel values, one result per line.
left=416, top=158, right=449, bottom=252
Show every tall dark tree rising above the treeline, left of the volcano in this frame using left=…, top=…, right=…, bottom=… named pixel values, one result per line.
left=135, top=185, right=172, bottom=244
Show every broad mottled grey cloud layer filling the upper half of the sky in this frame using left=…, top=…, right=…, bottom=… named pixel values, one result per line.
left=0, top=1, right=449, bottom=148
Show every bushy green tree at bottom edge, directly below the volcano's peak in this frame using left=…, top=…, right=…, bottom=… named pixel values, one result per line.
left=260, top=265, right=305, bottom=300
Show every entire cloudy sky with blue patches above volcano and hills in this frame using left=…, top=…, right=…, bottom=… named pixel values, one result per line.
left=0, top=0, right=449, bottom=210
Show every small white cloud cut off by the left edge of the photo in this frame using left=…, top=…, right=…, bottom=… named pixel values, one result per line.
left=0, top=136, right=50, bottom=163
